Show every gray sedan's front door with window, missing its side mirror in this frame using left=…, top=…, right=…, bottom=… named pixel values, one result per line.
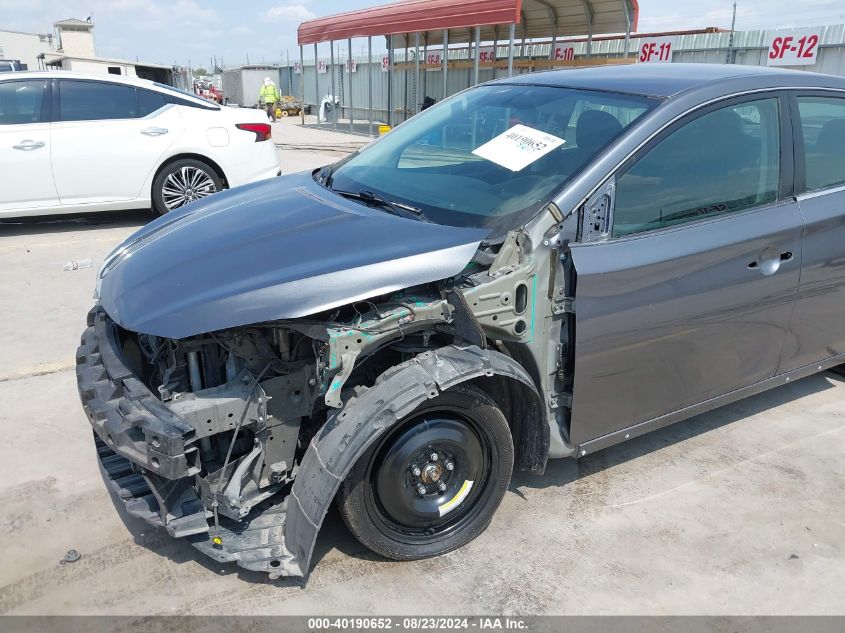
left=570, top=94, right=803, bottom=445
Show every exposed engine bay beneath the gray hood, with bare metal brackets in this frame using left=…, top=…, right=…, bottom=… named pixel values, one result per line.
left=121, top=288, right=454, bottom=520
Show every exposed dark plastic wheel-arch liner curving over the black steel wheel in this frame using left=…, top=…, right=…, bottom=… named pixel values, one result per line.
left=278, top=346, right=549, bottom=575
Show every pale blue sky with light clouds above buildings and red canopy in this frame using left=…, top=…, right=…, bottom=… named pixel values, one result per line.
left=0, top=0, right=845, bottom=67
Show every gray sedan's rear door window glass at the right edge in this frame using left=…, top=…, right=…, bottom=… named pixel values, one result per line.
left=798, top=97, right=845, bottom=191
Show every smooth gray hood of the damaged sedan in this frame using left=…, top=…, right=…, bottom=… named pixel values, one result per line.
left=97, top=172, right=487, bottom=338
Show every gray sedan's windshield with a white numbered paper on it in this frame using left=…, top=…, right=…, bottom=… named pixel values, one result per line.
left=327, top=84, right=658, bottom=236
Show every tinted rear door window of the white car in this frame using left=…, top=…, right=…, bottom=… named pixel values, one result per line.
left=59, top=79, right=138, bottom=121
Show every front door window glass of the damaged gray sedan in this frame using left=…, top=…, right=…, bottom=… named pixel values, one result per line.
left=613, top=98, right=780, bottom=237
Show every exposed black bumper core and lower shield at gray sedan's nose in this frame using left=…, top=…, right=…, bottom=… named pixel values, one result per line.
left=76, top=307, right=303, bottom=577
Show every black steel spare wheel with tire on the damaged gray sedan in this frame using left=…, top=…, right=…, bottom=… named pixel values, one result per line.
left=336, top=385, right=513, bottom=560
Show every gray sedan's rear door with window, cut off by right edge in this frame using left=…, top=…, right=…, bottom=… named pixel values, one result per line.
left=778, top=92, right=845, bottom=372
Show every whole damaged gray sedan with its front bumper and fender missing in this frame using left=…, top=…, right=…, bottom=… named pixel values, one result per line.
left=77, top=64, right=845, bottom=577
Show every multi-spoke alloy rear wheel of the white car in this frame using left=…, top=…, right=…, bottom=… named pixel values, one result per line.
left=152, top=158, right=223, bottom=215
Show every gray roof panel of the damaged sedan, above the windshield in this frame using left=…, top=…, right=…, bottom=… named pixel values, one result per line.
left=496, top=63, right=845, bottom=98
